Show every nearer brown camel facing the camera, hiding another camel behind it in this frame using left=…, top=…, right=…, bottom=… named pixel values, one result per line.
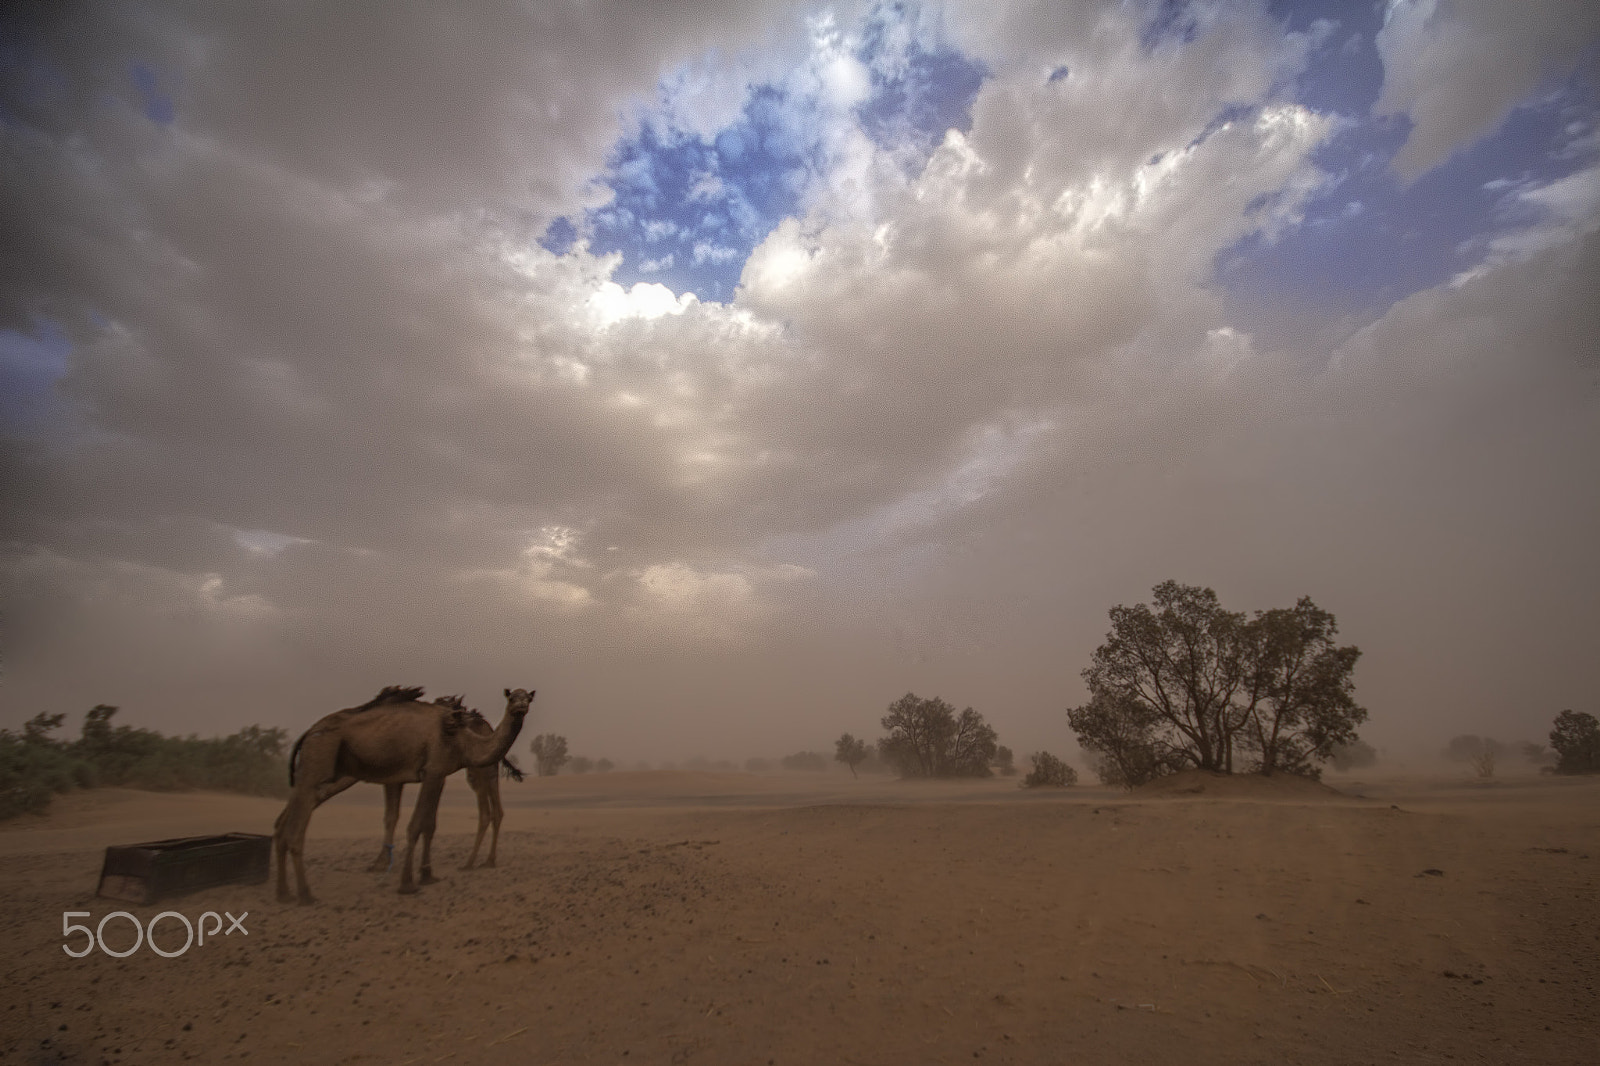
left=274, top=687, right=534, bottom=903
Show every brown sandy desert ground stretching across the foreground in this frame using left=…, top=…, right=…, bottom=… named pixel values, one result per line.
left=0, top=773, right=1600, bottom=1064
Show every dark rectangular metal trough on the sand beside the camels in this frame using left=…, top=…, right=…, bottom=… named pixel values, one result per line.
left=94, top=832, right=272, bottom=903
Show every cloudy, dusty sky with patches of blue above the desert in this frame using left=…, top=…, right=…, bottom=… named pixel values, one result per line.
left=0, top=0, right=1600, bottom=763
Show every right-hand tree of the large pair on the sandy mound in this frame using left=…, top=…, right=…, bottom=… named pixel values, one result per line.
left=1240, top=597, right=1366, bottom=776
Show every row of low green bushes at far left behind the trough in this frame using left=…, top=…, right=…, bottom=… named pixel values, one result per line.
left=0, top=703, right=288, bottom=818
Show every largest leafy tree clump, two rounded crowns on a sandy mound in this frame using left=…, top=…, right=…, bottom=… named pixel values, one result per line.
left=1067, top=581, right=1366, bottom=787
